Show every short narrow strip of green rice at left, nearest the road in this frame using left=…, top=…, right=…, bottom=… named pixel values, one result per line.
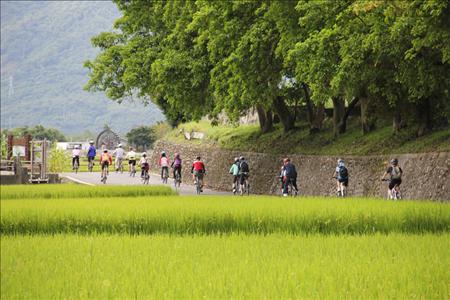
left=0, top=184, right=175, bottom=199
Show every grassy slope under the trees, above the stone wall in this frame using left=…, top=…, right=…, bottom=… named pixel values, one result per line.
left=165, top=120, right=450, bottom=155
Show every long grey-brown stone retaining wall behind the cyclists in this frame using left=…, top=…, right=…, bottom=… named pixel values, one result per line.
left=150, top=141, right=450, bottom=201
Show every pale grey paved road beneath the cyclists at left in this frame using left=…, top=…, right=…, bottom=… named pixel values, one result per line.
left=61, top=172, right=232, bottom=195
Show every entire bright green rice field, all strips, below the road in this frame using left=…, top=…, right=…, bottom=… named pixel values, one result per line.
left=0, top=185, right=450, bottom=299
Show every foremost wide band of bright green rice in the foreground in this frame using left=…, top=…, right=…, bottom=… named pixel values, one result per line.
left=1, top=234, right=450, bottom=299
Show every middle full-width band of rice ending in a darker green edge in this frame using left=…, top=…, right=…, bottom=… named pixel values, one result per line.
left=0, top=196, right=450, bottom=235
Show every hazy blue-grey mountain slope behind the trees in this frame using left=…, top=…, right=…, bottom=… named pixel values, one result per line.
left=0, top=1, right=164, bottom=135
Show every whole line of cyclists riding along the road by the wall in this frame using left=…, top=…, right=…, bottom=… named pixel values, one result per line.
left=72, top=141, right=403, bottom=199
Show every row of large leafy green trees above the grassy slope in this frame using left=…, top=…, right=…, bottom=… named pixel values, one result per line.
left=85, top=0, right=450, bottom=136
